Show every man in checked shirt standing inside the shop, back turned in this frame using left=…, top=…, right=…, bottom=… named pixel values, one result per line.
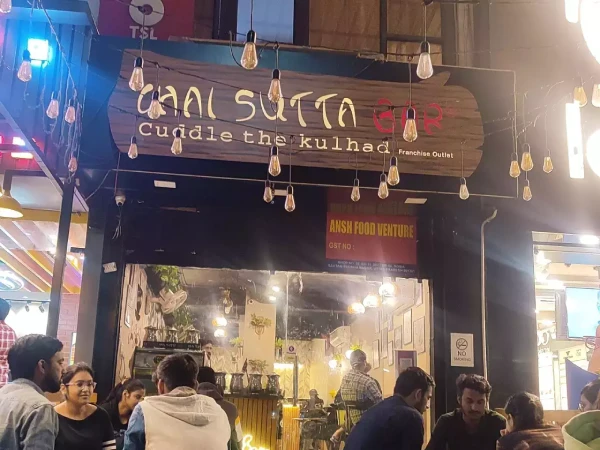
left=331, top=350, right=383, bottom=444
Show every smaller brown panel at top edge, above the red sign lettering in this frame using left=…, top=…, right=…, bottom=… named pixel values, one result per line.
left=387, top=0, right=442, bottom=37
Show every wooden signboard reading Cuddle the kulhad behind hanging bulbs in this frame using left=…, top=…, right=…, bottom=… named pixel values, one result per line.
left=109, top=49, right=484, bottom=177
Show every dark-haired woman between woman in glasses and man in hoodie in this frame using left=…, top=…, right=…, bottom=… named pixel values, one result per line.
left=100, top=378, right=146, bottom=450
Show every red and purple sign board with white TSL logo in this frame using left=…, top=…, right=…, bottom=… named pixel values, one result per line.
left=98, top=0, right=195, bottom=40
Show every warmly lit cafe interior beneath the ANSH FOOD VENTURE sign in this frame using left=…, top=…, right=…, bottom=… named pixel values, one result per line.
left=115, top=264, right=432, bottom=449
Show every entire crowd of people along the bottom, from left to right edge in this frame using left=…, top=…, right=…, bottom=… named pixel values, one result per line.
left=0, top=302, right=600, bottom=450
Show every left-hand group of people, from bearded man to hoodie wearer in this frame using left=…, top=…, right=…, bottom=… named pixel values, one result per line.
left=0, top=335, right=242, bottom=450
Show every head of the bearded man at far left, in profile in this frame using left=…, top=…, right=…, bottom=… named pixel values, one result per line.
left=8, top=334, right=64, bottom=393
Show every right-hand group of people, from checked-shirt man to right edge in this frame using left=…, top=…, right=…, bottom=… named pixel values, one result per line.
left=332, top=350, right=600, bottom=450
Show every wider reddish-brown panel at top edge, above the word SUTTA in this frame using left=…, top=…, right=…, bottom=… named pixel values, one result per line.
left=309, top=0, right=379, bottom=52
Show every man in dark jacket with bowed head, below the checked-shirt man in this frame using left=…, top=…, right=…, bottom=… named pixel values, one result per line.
left=345, top=367, right=435, bottom=450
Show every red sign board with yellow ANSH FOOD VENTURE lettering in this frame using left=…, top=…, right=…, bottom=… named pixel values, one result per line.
left=326, top=212, right=417, bottom=276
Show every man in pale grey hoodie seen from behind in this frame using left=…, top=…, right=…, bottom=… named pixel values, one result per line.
left=124, top=353, right=231, bottom=450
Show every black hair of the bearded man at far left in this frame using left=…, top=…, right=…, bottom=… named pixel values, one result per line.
left=8, top=334, right=63, bottom=381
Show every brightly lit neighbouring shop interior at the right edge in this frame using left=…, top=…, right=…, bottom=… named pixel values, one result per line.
left=533, top=232, right=600, bottom=410
